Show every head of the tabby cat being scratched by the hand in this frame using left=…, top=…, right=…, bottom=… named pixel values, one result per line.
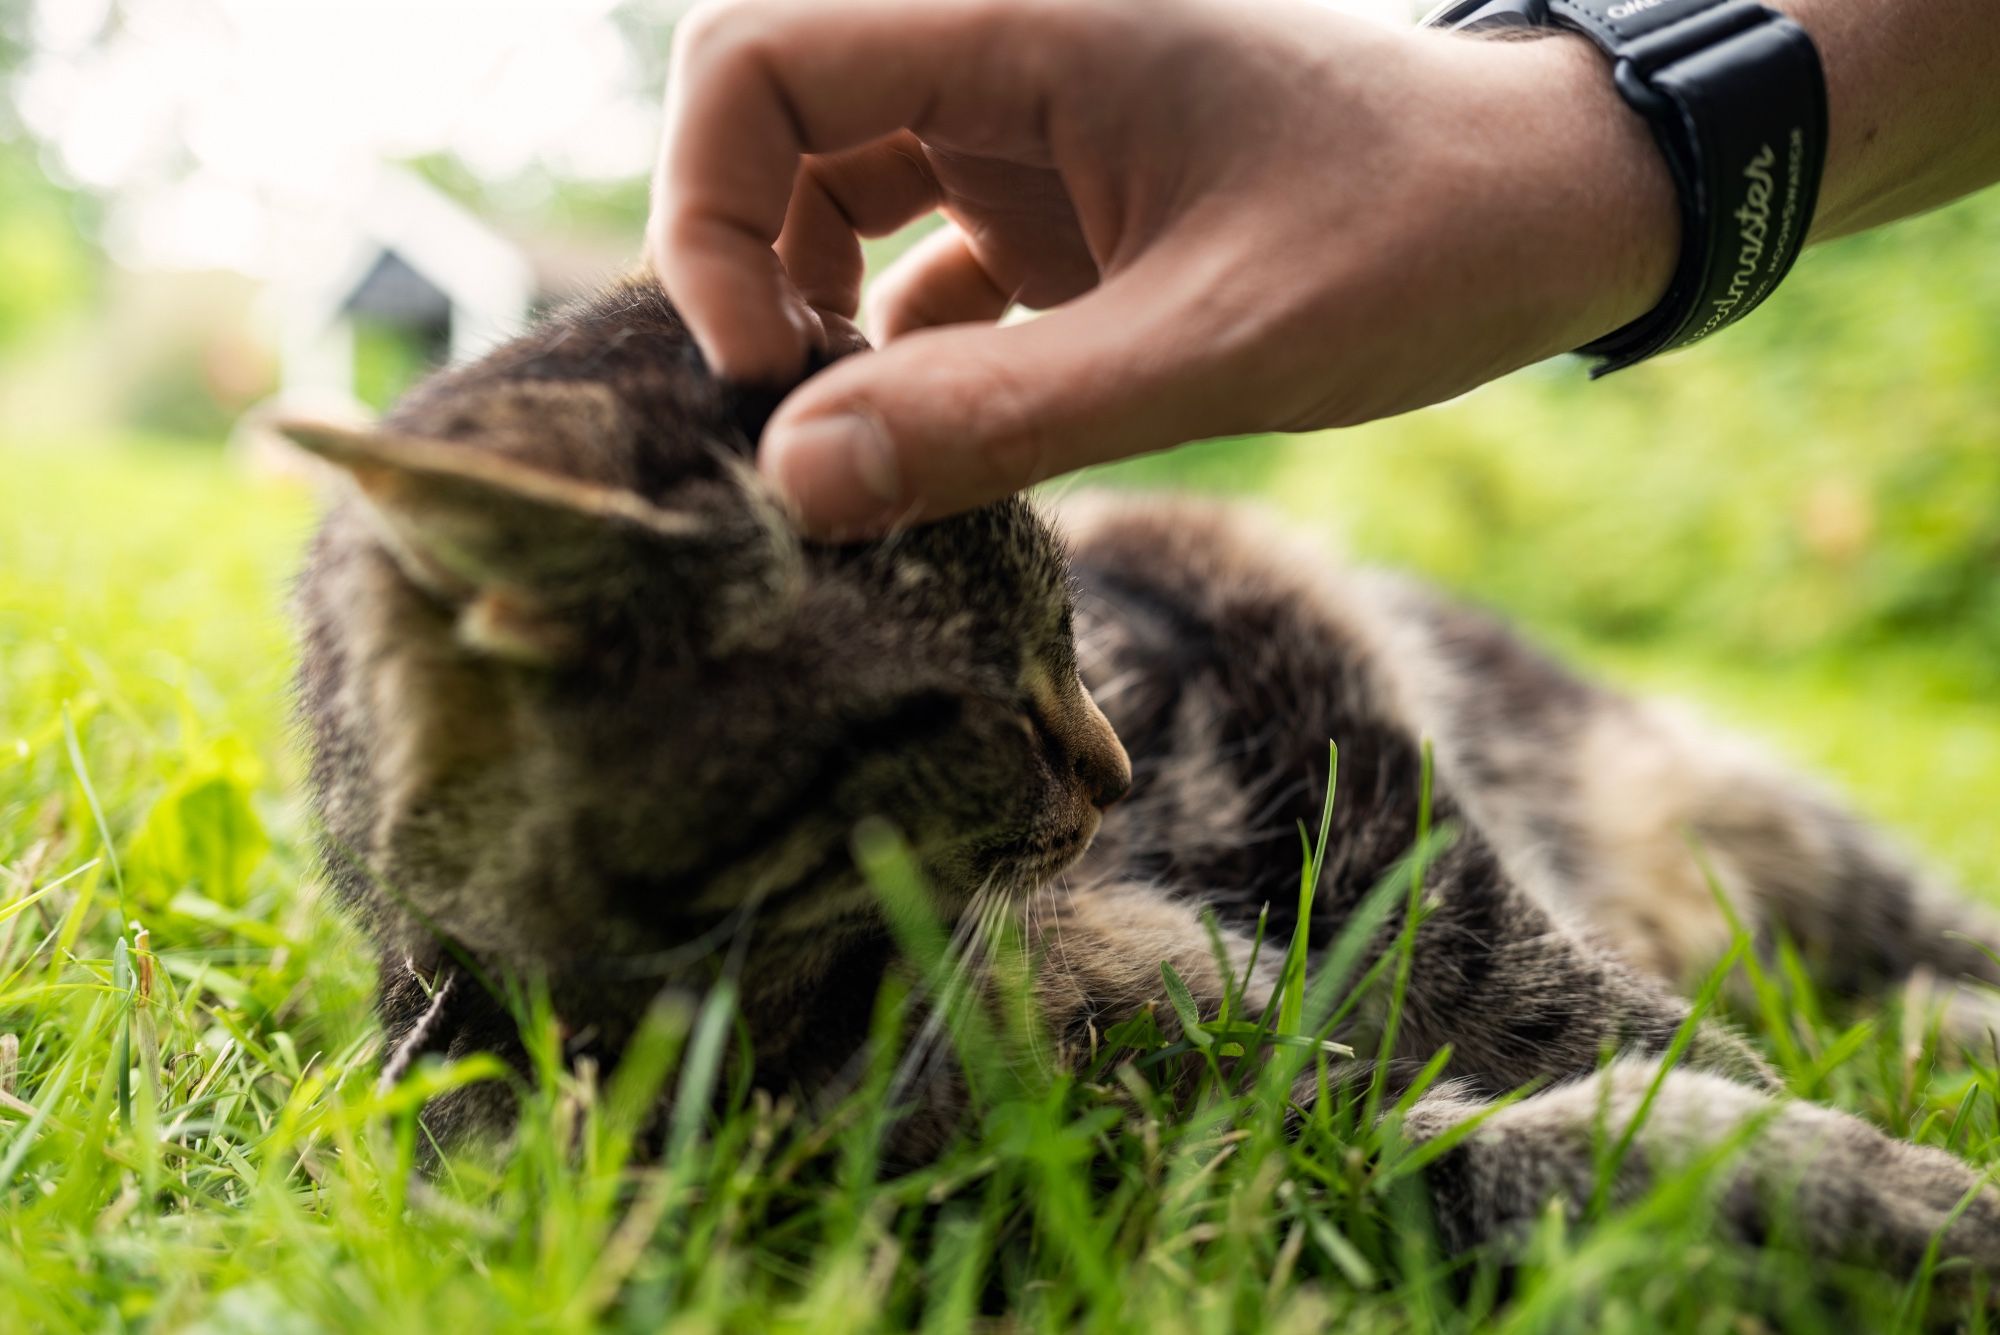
left=288, top=283, right=1130, bottom=971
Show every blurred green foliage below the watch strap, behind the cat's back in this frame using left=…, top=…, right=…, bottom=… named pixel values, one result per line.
left=1114, top=192, right=2000, bottom=687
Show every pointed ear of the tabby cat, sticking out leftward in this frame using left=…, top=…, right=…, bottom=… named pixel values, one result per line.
left=278, top=422, right=796, bottom=662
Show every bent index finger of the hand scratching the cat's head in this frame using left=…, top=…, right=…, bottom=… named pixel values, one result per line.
left=646, top=0, right=1046, bottom=380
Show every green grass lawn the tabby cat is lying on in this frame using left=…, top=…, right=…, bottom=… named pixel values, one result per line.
left=0, top=429, right=2000, bottom=1333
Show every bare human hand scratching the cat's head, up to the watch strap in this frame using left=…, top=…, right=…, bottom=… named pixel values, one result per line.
left=646, top=0, right=1678, bottom=538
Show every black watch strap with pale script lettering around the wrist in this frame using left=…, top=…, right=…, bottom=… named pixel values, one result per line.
left=1424, top=0, right=1826, bottom=376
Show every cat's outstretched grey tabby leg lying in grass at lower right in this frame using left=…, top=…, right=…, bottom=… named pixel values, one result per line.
left=1404, top=1057, right=2000, bottom=1281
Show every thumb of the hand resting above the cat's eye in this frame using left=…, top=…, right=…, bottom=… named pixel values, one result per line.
left=758, top=286, right=1220, bottom=540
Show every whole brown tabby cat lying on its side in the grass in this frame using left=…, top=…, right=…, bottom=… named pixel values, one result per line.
left=286, top=278, right=2000, bottom=1271
